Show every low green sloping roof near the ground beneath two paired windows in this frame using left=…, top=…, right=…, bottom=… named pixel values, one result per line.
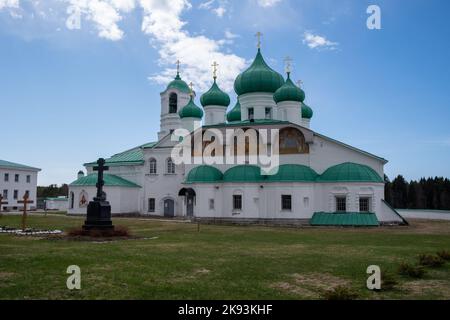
left=310, top=212, right=380, bottom=227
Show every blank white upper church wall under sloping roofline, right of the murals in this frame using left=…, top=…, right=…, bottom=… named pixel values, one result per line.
left=310, top=136, right=384, bottom=177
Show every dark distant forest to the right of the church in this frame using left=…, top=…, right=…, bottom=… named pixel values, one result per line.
left=384, top=175, right=450, bottom=210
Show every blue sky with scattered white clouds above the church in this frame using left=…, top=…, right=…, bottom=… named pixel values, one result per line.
left=0, top=0, right=450, bottom=185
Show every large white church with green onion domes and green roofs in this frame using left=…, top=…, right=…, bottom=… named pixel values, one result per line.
left=68, top=42, right=407, bottom=226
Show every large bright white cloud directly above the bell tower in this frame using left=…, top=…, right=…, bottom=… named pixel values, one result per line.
left=141, top=0, right=245, bottom=92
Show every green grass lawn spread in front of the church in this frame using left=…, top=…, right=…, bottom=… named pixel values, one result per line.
left=0, top=214, right=450, bottom=299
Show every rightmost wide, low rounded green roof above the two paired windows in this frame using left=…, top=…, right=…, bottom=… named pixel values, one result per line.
left=317, top=162, right=383, bottom=183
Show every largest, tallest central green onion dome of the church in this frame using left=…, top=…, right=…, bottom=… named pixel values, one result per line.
left=234, top=49, right=284, bottom=95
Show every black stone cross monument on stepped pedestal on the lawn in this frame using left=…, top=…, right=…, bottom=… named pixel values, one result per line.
left=83, top=158, right=114, bottom=230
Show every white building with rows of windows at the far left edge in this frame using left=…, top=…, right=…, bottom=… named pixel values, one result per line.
left=0, top=160, right=41, bottom=211
